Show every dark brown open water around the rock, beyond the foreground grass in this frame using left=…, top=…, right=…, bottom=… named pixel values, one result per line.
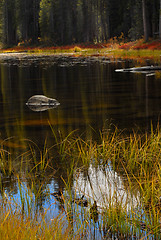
left=0, top=54, right=161, bottom=141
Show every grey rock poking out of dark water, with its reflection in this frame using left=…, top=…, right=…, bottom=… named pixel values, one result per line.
left=26, top=95, right=60, bottom=112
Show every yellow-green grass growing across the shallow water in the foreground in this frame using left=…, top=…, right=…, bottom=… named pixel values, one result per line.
left=0, top=128, right=161, bottom=239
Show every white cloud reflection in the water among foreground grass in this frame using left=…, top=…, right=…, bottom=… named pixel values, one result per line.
left=74, top=164, right=140, bottom=211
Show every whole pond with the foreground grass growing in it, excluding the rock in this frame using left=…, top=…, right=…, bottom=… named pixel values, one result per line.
left=0, top=53, right=161, bottom=239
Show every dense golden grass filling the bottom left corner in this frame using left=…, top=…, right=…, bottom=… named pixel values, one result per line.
left=0, top=210, right=74, bottom=240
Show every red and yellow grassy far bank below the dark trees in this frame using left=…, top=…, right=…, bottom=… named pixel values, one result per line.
left=0, top=38, right=161, bottom=62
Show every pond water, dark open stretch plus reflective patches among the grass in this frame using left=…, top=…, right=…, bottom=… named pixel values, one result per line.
left=0, top=53, right=161, bottom=239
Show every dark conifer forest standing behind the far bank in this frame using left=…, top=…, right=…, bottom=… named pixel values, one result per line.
left=0, top=0, right=161, bottom=45
